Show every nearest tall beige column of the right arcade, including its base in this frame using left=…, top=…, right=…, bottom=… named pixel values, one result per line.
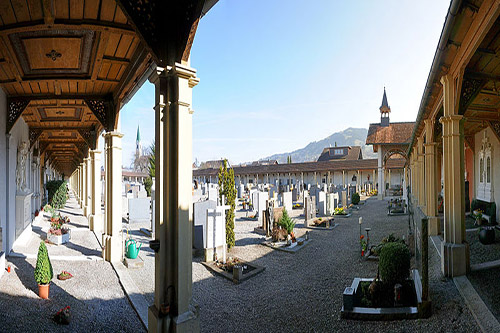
left=439, top=74, right=469, bottom=277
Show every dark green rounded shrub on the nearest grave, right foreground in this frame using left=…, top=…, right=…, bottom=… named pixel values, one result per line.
left=378, top=242, right=411, bottom=286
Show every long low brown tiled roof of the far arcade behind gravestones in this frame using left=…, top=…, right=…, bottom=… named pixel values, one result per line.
left=193, top=158, right=405, bottom=177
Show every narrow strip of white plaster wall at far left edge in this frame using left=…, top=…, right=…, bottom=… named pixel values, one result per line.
left=0, top=88, right=8, bottom=251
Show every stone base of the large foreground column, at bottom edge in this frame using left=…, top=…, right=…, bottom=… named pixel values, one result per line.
left=148, top=300, right=200, bottom=333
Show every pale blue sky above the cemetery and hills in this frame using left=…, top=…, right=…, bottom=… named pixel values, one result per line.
left=121, top=0, right=449, bottom=166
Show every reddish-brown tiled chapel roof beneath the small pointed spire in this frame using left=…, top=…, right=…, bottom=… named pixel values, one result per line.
left=366, top=122, right=415, bottom=145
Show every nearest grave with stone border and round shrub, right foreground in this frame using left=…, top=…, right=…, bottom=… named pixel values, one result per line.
left=341, top=209, right=431, bottom=320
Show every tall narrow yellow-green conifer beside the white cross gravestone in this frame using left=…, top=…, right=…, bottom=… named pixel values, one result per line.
left=217, top=159, right=236, bottom=248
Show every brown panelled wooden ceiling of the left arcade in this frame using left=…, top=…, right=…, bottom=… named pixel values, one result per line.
left=0, top=0, right=152, bottom=175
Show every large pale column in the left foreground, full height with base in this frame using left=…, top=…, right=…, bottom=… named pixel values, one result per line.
left=148, top=64, right=200, bottom=332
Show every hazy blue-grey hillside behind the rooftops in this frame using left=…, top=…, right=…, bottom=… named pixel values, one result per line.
left=263, top=127, right=377, bottom=164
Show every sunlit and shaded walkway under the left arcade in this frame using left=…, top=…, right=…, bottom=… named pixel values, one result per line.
left=0, top=195, right=145, bottom=332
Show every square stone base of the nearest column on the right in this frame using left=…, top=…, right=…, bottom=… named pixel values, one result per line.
left=441, top=242, right=470, bottom=277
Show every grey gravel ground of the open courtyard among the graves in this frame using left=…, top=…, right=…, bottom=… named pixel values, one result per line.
left=189, top=198, right=479, bottom=332
